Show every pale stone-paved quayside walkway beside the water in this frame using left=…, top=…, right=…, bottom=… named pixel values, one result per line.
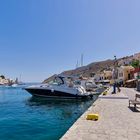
left=61, top=88, right=140, bottom=140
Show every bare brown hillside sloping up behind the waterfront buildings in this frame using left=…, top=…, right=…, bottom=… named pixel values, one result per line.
left=43, top=53, right=140, bottom=83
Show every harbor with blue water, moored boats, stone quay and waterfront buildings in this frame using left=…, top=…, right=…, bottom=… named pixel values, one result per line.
left=0, top=53, right=140, bottom=140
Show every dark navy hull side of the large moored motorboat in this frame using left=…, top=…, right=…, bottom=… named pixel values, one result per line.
left=25, top=88, right=92, bottom=99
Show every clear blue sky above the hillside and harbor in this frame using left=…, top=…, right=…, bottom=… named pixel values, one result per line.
left=0, top=0, right=140, bottom=81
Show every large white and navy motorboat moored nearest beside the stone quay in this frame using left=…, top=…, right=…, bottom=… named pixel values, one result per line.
left=24, top=75, right=93, bottom=99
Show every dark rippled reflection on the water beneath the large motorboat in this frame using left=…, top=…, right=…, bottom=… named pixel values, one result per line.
left=26, top=96, right=97, bottom=120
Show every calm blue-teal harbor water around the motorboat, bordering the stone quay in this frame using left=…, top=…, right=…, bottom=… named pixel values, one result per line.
left=0, top=87, right=97, bottom=140
